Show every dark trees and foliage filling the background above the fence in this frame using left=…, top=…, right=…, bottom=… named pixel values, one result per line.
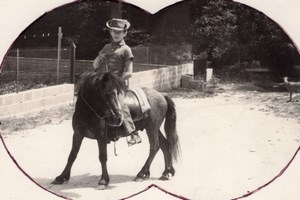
left=9, top=0, right=300, bottom=82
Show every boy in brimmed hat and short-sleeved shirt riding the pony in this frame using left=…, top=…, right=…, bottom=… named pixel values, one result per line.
left=93, top=18, right=142, bottom=146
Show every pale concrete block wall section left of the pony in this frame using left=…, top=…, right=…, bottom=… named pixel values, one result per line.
left=0, top=84, right=74, bottom=118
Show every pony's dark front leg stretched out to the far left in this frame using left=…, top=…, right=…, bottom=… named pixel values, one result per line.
left=52, top=133, right=83, bottom=184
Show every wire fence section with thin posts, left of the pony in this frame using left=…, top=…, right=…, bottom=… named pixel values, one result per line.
left=0, top=48, right=71, bottom=94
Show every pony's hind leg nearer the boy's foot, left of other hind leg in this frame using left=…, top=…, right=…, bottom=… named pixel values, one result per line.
left=134, top=130, right=159, bottom=181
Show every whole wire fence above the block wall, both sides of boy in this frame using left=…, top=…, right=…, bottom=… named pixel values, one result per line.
left=0, top=45, right=192, bottom=95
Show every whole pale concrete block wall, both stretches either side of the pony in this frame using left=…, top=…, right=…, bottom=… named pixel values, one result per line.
left=0, top=63, right=193, bottom=118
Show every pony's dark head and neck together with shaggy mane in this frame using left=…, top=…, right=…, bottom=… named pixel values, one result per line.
left=77, top=72, right=124, bottom=126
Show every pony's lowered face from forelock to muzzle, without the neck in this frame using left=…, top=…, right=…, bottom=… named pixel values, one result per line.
left=99, top=72, right=124, bottom=126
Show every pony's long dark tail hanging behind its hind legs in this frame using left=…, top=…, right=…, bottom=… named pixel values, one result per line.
left=164, top=96, right=180, bottom=161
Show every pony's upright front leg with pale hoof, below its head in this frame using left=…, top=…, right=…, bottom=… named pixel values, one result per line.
left=96, top=138, right=109, bottom=190
